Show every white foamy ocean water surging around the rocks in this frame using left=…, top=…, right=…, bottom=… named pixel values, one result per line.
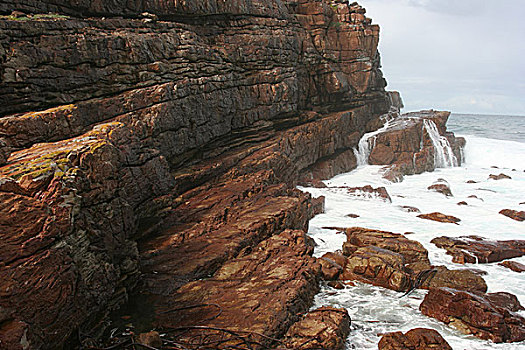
left=301, top=114, right=525, bottom=350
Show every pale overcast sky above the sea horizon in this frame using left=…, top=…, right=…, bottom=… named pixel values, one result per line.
left=359, top=0, right=525, bottom=115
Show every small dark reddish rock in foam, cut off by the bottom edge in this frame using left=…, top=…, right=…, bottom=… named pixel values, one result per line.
left=378, top=328, right=452, bottom=350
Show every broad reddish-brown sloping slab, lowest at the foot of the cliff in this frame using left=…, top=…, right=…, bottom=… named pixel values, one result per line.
left=151, top=230, right=320, bottom=346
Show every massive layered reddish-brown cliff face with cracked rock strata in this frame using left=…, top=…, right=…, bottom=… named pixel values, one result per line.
left=0, top=0, right=390, bottom=349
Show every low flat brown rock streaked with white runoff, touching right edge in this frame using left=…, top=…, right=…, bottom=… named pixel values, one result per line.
left=430, top=236, right=525, bottom=264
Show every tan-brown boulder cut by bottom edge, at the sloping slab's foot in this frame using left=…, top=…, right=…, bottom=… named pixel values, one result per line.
left=279, top=306, right=350, bottom=350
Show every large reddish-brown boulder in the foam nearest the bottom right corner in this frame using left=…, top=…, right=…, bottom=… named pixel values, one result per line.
left=419, top=288, right=525, bottom=343
